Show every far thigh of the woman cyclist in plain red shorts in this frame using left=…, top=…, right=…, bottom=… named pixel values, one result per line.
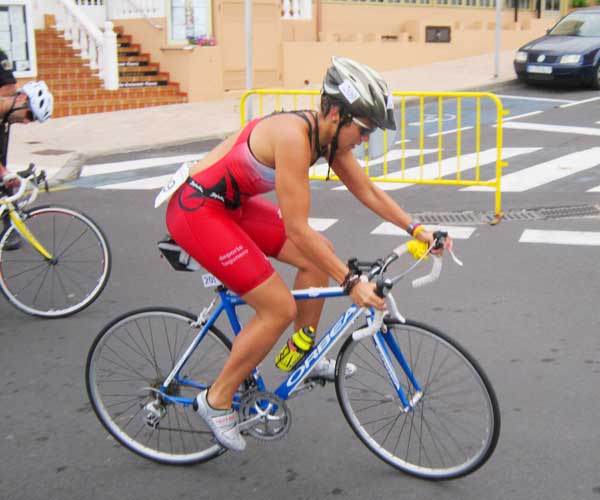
left=240, top=196, right=287, bottom=257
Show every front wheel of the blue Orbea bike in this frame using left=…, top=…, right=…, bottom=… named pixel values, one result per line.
left=335, top=320, right=500, bottom=480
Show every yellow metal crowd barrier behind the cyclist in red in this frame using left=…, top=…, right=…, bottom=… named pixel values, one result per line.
left=240, top=89, right=508, bottom=220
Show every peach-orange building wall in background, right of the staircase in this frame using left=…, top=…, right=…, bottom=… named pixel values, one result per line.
left=115, top=5, right=555, bottom=102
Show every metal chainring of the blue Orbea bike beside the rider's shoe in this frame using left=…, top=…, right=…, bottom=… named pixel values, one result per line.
left=238, top=390, right=292, bottom=441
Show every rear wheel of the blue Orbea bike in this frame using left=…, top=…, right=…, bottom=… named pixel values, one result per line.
left=85, top=307, right=231, bottom=465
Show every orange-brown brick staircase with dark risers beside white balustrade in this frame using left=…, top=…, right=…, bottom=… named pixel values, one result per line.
left=35, top=25, right=187, bottom=118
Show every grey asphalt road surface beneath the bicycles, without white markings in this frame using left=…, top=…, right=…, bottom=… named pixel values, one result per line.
left=0, top=82, right=600, bottom=500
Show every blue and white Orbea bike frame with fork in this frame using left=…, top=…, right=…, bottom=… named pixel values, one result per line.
left=160, top=287, right=422, bottom=412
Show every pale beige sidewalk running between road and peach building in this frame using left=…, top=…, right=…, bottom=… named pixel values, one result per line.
left=8, top=50, right=515, bottom=184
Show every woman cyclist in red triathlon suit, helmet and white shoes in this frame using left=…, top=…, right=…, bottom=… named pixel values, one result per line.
left=166, top=57, right=451, bottom=451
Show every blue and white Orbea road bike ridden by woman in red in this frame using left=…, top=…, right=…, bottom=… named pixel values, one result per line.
left=86, top=233, right=500, bottom=480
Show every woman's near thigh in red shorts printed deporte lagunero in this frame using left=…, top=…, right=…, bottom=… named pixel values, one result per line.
left=167, top=197, right=275, bottom=295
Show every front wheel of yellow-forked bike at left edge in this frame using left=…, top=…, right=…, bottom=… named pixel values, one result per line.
left=0, top=205, right=112, bottom=318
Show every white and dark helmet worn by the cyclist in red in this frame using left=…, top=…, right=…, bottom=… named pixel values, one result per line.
left=321, top=57, right=396, bottom=130
